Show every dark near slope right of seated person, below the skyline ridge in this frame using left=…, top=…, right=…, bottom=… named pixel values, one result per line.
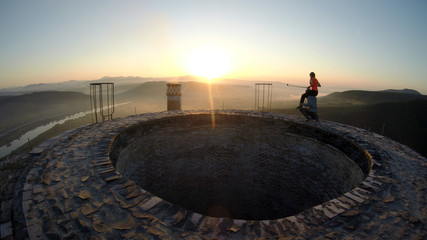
left=275, top=99, right=427, bottom=157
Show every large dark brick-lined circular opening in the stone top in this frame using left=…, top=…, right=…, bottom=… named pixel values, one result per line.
left=110, top=114, right=369, bottom=220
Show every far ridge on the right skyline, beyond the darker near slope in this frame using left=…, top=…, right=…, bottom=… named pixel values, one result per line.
left=319, top=89, right=427, bottom=105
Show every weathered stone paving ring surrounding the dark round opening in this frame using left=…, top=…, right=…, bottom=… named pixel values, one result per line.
left=5, top=110, right=427, bottom=239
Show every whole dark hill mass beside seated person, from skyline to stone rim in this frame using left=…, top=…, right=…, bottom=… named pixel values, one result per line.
left=274, top=90, right=427, bottom=157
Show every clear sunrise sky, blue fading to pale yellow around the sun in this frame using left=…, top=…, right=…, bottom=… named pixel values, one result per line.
left=0, top=0, right=427, bottom=94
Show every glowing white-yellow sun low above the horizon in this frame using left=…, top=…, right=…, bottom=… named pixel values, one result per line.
left=187, top=46, right=230, bottom=81
